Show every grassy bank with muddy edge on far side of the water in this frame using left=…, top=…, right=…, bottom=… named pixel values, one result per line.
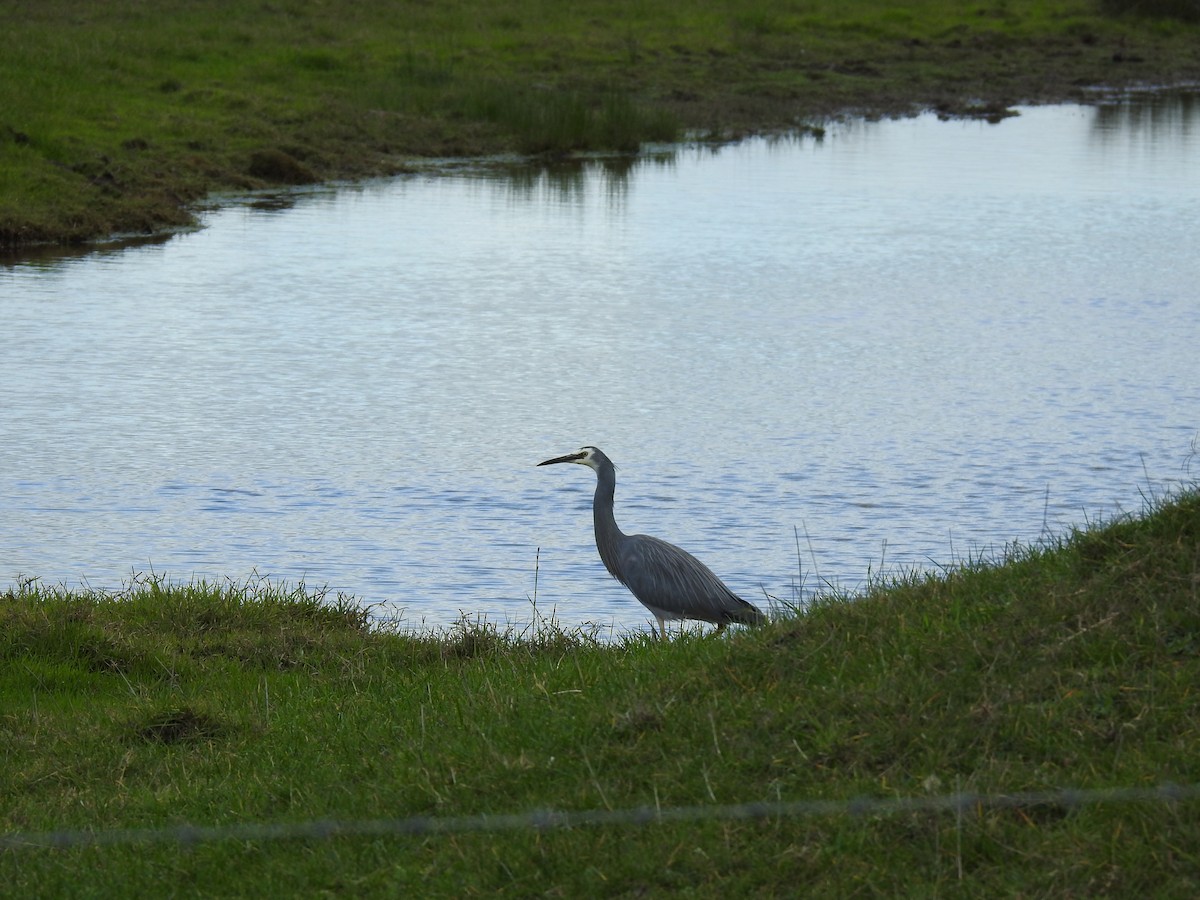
left=0, top=0, right=1200, bottom=248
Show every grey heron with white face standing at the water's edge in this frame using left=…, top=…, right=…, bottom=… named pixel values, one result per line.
left=538, top=446, right=767, bottom=640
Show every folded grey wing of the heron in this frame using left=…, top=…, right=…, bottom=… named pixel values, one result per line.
left=618, top=534, right=762, bottom=624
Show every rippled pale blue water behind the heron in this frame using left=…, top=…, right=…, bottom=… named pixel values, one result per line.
left=0, top=96, right=1200, bottom=630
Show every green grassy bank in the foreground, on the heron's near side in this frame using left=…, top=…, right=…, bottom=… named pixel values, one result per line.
left=0, top=492, right=1200, bottom=896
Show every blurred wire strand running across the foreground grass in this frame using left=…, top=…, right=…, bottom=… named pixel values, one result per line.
left=0, top=784, right=1200, bottom=851
